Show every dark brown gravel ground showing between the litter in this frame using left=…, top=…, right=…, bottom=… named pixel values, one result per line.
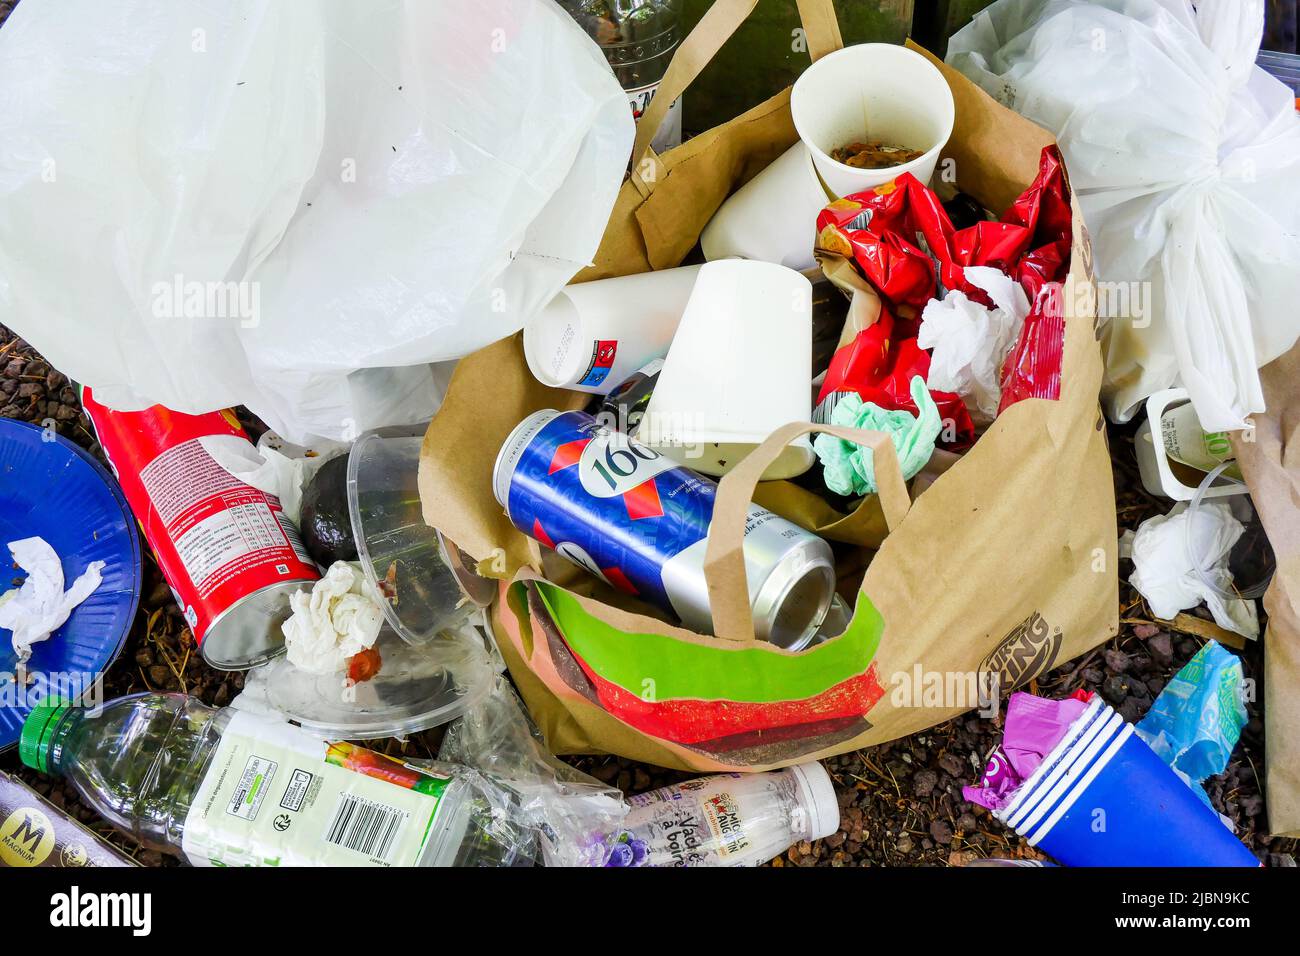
left=0, top=0, right=1297, bottom=866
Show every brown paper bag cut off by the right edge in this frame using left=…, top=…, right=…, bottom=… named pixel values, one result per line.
left=1232, top=346, right=1300, bottom=836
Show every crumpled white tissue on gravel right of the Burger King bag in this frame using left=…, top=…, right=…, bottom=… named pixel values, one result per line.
left=1121, top=501, right=1260, bottom=639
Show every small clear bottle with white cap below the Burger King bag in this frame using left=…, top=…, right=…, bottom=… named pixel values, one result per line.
left=606, top=762, right=840, bottom=866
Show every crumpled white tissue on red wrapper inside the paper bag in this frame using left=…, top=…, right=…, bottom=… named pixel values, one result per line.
left=917, top=265, right=1030, bottom=425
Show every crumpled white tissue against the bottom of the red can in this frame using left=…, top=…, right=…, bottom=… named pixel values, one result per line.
left=281, top=561, right=384, bottom=674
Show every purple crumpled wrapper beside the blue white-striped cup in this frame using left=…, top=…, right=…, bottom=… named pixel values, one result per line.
left=962, top=693, right=1088, bottom=810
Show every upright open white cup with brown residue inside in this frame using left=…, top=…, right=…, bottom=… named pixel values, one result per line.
left=790, top=43, right=957, bottom=196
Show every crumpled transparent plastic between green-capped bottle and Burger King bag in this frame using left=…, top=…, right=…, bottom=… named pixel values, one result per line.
left=438, top=676, right=628, bottom=866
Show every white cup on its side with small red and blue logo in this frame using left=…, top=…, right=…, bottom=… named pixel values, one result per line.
left=524, top=265, right=699, bottom=395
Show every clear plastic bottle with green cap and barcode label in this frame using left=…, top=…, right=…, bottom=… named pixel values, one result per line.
left=20, top=693, right=532, bottom=866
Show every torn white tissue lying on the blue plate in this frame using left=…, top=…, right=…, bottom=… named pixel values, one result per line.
left=0, top=537, right=104, bottom=663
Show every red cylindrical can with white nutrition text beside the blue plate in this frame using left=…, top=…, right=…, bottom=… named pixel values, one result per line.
left=82, top=388, right=320, bottom=670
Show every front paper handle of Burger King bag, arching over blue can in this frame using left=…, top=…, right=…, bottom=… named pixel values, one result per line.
left=705, top=421, right=911, bottom=641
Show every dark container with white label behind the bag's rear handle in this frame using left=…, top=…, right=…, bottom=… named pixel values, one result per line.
left=560, top=0, right=681, bottom=152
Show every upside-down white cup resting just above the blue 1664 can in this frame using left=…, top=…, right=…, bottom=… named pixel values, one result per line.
left=637, top=259, right=814, bottom=479
